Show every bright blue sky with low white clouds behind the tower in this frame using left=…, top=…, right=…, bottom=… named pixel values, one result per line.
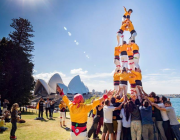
left=0, top=0, right=180, bottom=94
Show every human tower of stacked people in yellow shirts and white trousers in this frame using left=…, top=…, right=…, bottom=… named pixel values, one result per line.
left=114, top=7, right=142, bottom=99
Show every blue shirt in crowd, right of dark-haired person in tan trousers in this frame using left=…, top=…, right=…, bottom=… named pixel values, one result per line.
left=139, top=106, right=153, bottom=125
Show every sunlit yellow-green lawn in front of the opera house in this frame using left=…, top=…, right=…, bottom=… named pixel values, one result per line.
left=0, top=110, right=97, bottom=140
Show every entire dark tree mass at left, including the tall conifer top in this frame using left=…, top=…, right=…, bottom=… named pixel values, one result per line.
left=0, top=18, right=34, bottom=105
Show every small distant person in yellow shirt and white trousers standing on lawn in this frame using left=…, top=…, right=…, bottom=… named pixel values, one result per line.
left=59, top=101, right=66, bottom=127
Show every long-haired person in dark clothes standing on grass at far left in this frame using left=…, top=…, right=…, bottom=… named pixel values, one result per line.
left=10, top=103, right=19, bottom=139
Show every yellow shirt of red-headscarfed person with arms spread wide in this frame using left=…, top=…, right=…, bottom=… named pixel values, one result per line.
left=63, top=95, right=100, bottom=123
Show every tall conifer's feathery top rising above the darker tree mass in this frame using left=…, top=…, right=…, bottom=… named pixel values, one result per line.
left=9, top=18, right=34, bottom=57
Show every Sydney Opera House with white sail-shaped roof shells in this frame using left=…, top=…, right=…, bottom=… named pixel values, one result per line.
left=34, top=73, right=89, bottom=96
